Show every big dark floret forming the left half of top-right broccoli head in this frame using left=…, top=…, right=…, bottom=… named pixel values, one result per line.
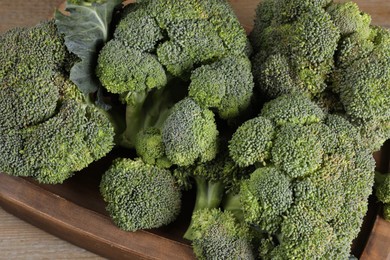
left=250, top=1, right=340, bottom=98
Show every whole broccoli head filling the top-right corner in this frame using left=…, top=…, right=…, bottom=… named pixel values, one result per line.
left=250, top=0, right=390, bottom=151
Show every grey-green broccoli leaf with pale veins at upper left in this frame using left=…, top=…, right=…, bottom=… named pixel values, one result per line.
left=55, top=0, right=122, bottom=94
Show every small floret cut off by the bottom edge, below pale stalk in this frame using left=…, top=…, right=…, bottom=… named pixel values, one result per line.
left=192, top=209, right=255, bottom=259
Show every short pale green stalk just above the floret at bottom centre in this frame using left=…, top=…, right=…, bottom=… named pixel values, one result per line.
left=183, top=176, right=225, bottom=241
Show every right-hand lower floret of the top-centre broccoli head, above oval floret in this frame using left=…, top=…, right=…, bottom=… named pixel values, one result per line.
left=189, top=56, right=254, bottom=119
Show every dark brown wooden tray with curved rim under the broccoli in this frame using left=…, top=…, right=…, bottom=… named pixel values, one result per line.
left=0, top=0, right=390, bottom=260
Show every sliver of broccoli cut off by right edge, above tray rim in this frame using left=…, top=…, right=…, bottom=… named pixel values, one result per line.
left=375, top=172, right=390, bottom=221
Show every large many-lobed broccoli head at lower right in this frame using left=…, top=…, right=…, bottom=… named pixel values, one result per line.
left=224, top=94, right=375, bottom=259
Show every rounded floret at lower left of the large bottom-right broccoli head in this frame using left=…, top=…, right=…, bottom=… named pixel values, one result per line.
left=240, top=166, right=293, bottom=233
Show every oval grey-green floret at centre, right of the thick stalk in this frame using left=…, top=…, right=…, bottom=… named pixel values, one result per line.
left=162, top=98, right=218, bottom=166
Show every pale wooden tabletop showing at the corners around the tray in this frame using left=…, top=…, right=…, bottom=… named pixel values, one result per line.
left=0, top=0, right=390, bottom=259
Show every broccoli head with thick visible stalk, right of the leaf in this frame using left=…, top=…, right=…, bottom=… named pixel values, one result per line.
left=96, top=0, right=254, bottom=162
